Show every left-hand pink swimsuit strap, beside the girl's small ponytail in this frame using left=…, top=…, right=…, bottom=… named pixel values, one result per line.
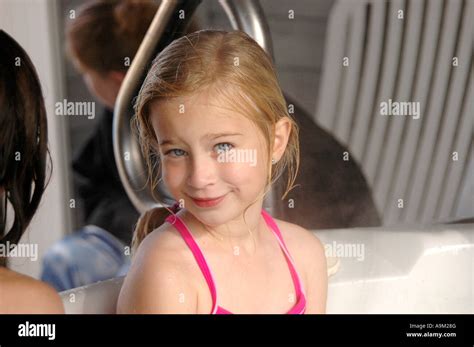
left=165, top=214, right=217, bottom=313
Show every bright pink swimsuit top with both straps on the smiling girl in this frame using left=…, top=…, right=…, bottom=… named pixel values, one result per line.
left=166, top=209, right=306, bottom=314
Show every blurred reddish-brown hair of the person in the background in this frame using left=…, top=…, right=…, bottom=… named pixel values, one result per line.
left=67, top=0, right=197, bottom=74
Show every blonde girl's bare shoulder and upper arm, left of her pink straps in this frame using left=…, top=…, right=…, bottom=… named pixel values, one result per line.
left=117, top=230, right=197, bottom=314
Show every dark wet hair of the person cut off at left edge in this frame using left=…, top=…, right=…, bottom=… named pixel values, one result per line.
left=0, top=30, right=48, bottom=262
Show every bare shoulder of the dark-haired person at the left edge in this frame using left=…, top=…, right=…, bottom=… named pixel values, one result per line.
left=0, top=268, right=64, bottom=314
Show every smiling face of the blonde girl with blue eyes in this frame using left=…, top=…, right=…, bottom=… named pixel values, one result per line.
left=151, top=89, right=268, bottom=227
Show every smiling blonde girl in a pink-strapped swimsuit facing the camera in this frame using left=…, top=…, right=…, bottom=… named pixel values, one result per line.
left=117, top=30, right=327, bottom=314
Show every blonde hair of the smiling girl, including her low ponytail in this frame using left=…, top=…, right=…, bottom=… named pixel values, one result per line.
left=131, top=30, right=299, bottom=253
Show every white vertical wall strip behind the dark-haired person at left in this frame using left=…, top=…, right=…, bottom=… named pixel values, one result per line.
left=0, top=0, right=71, bottom=277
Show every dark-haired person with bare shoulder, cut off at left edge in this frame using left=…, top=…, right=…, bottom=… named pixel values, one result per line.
left=0, top=30, right=64, bottom=313
